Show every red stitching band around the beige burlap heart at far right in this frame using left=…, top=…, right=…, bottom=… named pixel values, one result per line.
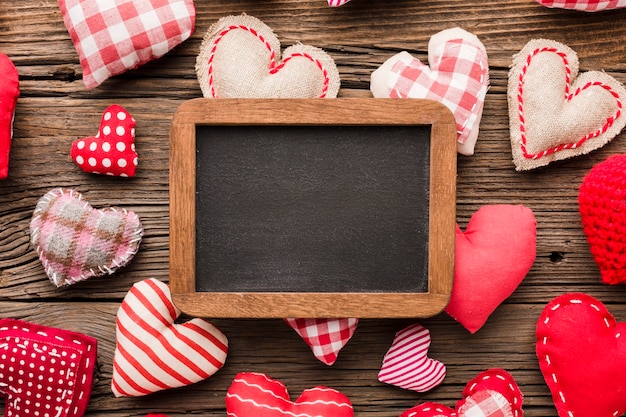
left=517, top=47, right=622, bottom=159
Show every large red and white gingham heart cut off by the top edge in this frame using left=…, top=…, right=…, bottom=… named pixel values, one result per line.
left=59, top=0, right=196, bottom=88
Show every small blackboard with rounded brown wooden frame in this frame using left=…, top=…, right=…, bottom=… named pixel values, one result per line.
left=170, top=99, right=456, bottom=317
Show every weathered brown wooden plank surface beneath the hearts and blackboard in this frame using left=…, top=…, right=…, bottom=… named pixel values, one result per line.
left=0, top=0, right=626, bottom=417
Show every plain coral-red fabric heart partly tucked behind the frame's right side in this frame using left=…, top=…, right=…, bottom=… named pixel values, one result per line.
left=438, top=204, right=537, bottom=333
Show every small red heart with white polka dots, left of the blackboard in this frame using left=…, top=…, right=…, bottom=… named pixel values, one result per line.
left=70, top=104, right=137, bottom=177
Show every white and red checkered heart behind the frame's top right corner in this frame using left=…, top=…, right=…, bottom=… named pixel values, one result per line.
left=370, top=28, right=489, bottom=155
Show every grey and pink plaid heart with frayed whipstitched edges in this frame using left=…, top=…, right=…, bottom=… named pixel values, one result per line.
left=30, top=188, right=143, bottom=287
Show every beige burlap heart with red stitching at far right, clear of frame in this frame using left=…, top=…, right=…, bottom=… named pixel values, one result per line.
left=508, top=39, right=626, bottom=171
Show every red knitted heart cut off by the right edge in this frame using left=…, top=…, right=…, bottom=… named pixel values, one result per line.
left=578, top=155, right=626, bottom=284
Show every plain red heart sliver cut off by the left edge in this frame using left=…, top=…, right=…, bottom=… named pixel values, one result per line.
left=0, top=53, right=20, bottom=180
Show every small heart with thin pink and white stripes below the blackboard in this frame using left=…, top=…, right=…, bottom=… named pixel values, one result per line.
left=378, top=323, right=446, bottom=392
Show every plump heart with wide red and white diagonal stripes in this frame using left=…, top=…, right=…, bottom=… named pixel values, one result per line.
left=111, top=278, right=228, bottom=397
